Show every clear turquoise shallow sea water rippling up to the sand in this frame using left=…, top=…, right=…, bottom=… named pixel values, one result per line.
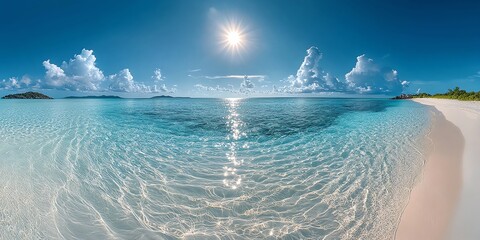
left=0, top=98, right=430, bottom=239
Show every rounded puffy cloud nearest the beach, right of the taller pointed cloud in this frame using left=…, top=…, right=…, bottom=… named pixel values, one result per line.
left=345, top=54, right=408, bottom=94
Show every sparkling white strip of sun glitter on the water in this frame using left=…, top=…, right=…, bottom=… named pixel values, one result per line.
left=223, top=98, right=247, bottom=189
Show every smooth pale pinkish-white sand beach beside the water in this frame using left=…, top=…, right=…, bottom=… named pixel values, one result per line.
left=396, top=99, right=480, bottom=240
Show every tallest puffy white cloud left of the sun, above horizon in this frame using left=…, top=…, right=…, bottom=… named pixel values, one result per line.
left=43, top=49, right=105, bottom=91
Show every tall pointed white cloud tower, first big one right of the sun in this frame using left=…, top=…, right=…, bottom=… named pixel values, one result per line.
left=287, top=47, right=344, bottom=93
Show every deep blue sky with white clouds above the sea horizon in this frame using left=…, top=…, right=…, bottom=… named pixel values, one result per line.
left=0, top=0, right=480, bottom=97
